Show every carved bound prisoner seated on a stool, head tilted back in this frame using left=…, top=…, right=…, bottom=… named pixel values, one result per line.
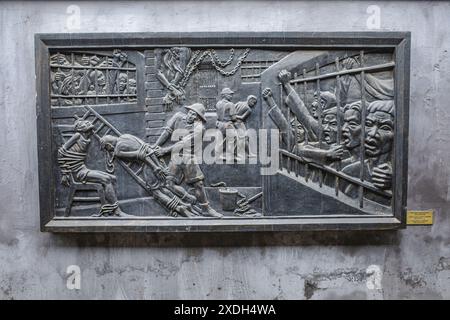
left=58, top=119, right=127, bottom=216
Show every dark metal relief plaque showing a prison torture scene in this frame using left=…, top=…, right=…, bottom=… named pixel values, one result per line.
left=37, top=34, right=409, bottom=231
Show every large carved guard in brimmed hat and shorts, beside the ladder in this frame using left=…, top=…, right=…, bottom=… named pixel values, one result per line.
left=155, top=103, right=222, bottom=218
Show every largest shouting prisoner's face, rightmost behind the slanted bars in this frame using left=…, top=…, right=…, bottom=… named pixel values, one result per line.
left=364, top=111, right=394, bottom=157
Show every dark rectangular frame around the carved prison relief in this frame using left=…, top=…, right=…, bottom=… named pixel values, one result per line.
left=35, top=32, right=410, bottom=232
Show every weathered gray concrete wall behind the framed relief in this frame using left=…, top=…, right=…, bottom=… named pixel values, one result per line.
left=0, top=1, right=450, bottom=299
